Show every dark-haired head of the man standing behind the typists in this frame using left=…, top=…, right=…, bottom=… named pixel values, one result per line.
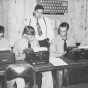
left=34, top=5, right=44, bottom=19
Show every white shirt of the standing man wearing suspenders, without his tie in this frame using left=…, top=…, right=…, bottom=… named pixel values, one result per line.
left=29, top=17, right=54, bottom=41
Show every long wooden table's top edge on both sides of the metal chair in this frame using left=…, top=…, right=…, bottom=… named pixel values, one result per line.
left=0, top=58, right=88, bottom=72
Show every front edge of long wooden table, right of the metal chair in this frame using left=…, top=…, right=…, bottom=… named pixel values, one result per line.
left=34, top=63, right=88, bottom=72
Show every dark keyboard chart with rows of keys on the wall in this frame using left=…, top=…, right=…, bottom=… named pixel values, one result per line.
left=37, top=0, right=68, bottom=15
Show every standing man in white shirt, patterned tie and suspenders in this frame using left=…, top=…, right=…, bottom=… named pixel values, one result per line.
left=29, top=5, right=54, bottom=47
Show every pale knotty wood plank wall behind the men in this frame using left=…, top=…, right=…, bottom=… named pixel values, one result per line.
left=0, top=0, right=88, bottom=46
